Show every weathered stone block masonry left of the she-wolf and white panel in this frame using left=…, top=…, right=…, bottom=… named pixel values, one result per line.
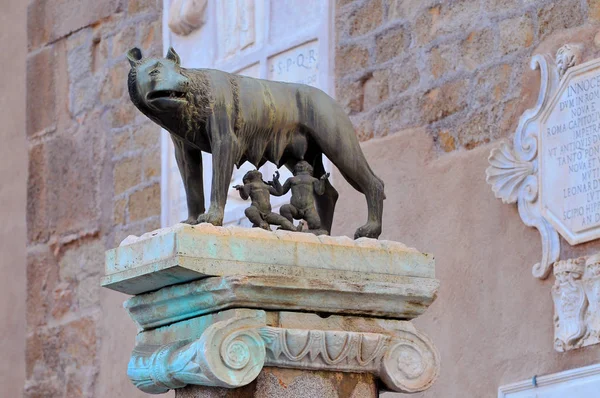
left=25, top=0, right=162, bottom=397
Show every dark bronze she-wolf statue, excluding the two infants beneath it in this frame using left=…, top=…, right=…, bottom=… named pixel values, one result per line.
left=127, top=48, right=385, bottom=238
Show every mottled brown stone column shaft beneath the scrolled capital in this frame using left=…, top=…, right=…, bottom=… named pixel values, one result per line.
left=175, top=367, right=379, bottom=398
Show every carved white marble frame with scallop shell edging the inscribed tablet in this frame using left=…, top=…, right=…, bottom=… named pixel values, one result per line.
left=486, top=44, right=597, bottom=279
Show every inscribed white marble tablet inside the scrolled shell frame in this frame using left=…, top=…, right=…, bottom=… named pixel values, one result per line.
left=539, top=62, right=600, bottom=245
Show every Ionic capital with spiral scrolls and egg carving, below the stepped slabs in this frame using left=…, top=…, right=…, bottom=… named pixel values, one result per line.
left=128, top=312, right=440, bottom=394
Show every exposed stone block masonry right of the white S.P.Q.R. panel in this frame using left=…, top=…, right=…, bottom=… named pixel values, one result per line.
left=335, top=0, right=600, bottom=153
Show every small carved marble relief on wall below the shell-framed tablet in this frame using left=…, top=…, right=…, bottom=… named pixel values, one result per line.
left=552, top=254, right=600, bottom=352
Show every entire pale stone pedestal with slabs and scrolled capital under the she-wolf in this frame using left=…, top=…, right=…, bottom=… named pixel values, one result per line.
left=103, top=224, right=440, bottom=397
